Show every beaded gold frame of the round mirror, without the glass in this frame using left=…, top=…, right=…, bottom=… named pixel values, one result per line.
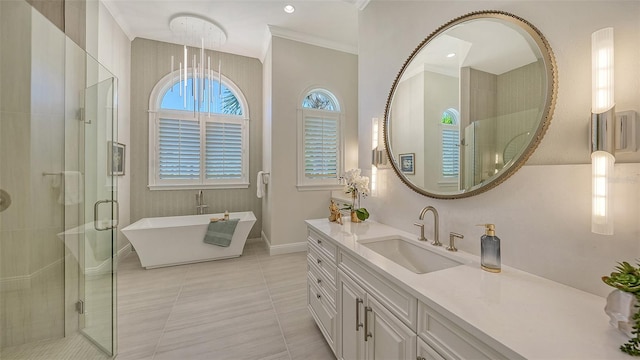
left=383, top=10, right=558, bottom=199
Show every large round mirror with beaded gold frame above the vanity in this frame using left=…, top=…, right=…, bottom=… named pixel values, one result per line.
left=384, top=11, right=557, bottom=199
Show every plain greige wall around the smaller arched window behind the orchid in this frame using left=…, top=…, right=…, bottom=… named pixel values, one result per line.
left=265, top=37, right=360, bottom=251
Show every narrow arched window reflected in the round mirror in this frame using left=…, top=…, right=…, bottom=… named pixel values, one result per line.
left=440, top=108, right=460, bottom=180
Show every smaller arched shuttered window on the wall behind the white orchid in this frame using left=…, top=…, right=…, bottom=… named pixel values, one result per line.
left=298, top=88, right=343, bottom=190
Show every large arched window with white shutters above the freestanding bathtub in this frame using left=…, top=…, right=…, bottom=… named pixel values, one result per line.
left=149, top=69, right=249, bottom=190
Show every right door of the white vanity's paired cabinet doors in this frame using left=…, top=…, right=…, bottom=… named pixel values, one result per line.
left=364, top=296, right=416, bottom=360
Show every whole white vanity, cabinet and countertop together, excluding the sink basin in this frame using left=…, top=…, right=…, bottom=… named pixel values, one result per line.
left=306, top=218, right=628, bottom=360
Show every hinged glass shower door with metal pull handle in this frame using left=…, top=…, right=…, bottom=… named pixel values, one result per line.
left=77, top=71, right=119, bottom=356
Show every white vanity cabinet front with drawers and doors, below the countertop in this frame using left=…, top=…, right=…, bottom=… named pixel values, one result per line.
left=307, top=224, right=521, bottom=360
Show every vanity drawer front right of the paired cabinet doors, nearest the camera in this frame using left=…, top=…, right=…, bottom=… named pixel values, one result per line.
left=418, top=302, right=522, bottom=359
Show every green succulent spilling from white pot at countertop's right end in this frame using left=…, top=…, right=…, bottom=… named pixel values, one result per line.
left=602, top=261, right=640, bottom=356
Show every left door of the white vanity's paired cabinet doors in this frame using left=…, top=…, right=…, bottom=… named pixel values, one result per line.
left=338, top=271, right=365, bottom=360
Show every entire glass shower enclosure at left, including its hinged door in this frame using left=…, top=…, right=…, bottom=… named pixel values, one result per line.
left=0, top=1, right=120, bottom=360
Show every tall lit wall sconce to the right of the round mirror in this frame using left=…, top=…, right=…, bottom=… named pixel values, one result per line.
left=591, top=27, right=616, bottom=235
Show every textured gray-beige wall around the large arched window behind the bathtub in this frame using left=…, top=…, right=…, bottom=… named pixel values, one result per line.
left=128, top=38, right=262, bottom=238
